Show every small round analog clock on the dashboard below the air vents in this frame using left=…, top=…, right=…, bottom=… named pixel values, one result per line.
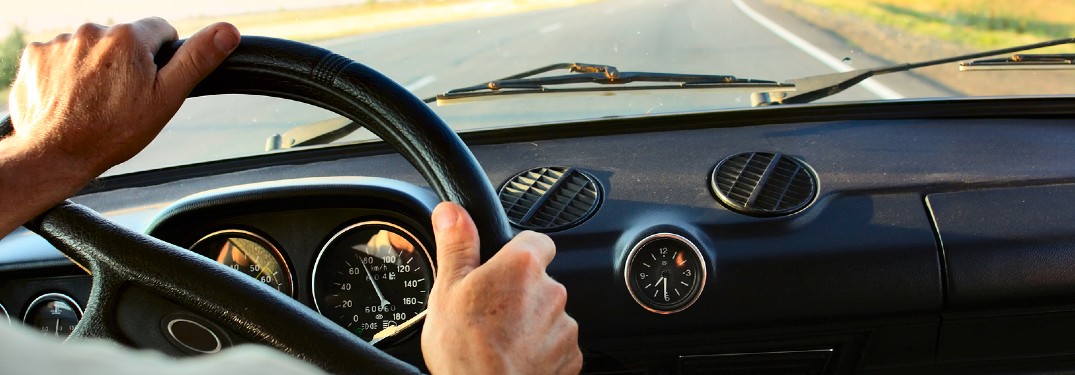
left=624, top=233, right=705, bottom=314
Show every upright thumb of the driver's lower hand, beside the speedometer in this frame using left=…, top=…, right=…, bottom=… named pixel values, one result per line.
left=432, top=202, right=481, bottom=286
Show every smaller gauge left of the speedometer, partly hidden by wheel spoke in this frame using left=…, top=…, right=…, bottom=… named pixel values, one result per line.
left=190, top=230, right=295, bottom=297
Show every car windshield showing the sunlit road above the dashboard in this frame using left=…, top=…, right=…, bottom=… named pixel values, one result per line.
left=0, top=0, right=1075, bottom=174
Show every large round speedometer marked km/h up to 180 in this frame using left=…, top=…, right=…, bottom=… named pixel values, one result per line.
left=313, top=221, right=435, bottom=343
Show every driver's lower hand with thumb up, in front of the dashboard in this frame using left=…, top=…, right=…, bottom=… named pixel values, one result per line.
left=421, top=203, right=583, bottom=374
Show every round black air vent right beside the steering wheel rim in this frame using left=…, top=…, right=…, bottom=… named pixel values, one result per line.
left=500, top=167, right=601, bottom=232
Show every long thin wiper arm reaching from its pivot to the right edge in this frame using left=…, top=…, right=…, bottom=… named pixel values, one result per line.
left=750, top=38, right=1075, bottom=106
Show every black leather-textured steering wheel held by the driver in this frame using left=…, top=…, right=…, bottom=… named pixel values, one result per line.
left=13, top=37, right=512, bottom=374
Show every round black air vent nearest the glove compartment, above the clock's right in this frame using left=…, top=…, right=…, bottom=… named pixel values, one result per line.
left=710, top=153, right=817, bottom=217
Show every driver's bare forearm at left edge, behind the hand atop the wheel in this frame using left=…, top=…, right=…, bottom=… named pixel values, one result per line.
left=0, top=135, right=94, bottom=235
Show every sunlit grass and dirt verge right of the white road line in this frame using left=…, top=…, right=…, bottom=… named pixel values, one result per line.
left=760, top=0, right=1075, bottom=96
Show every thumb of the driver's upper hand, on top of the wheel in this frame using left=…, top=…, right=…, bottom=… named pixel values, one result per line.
left=158, top=23, right=239, bottom=100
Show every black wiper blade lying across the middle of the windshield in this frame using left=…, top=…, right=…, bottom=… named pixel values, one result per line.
left=422, top=62, right=794, bottom=103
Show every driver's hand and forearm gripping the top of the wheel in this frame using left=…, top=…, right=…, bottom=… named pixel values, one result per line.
left=0, top=18, right=239, bottom=235
